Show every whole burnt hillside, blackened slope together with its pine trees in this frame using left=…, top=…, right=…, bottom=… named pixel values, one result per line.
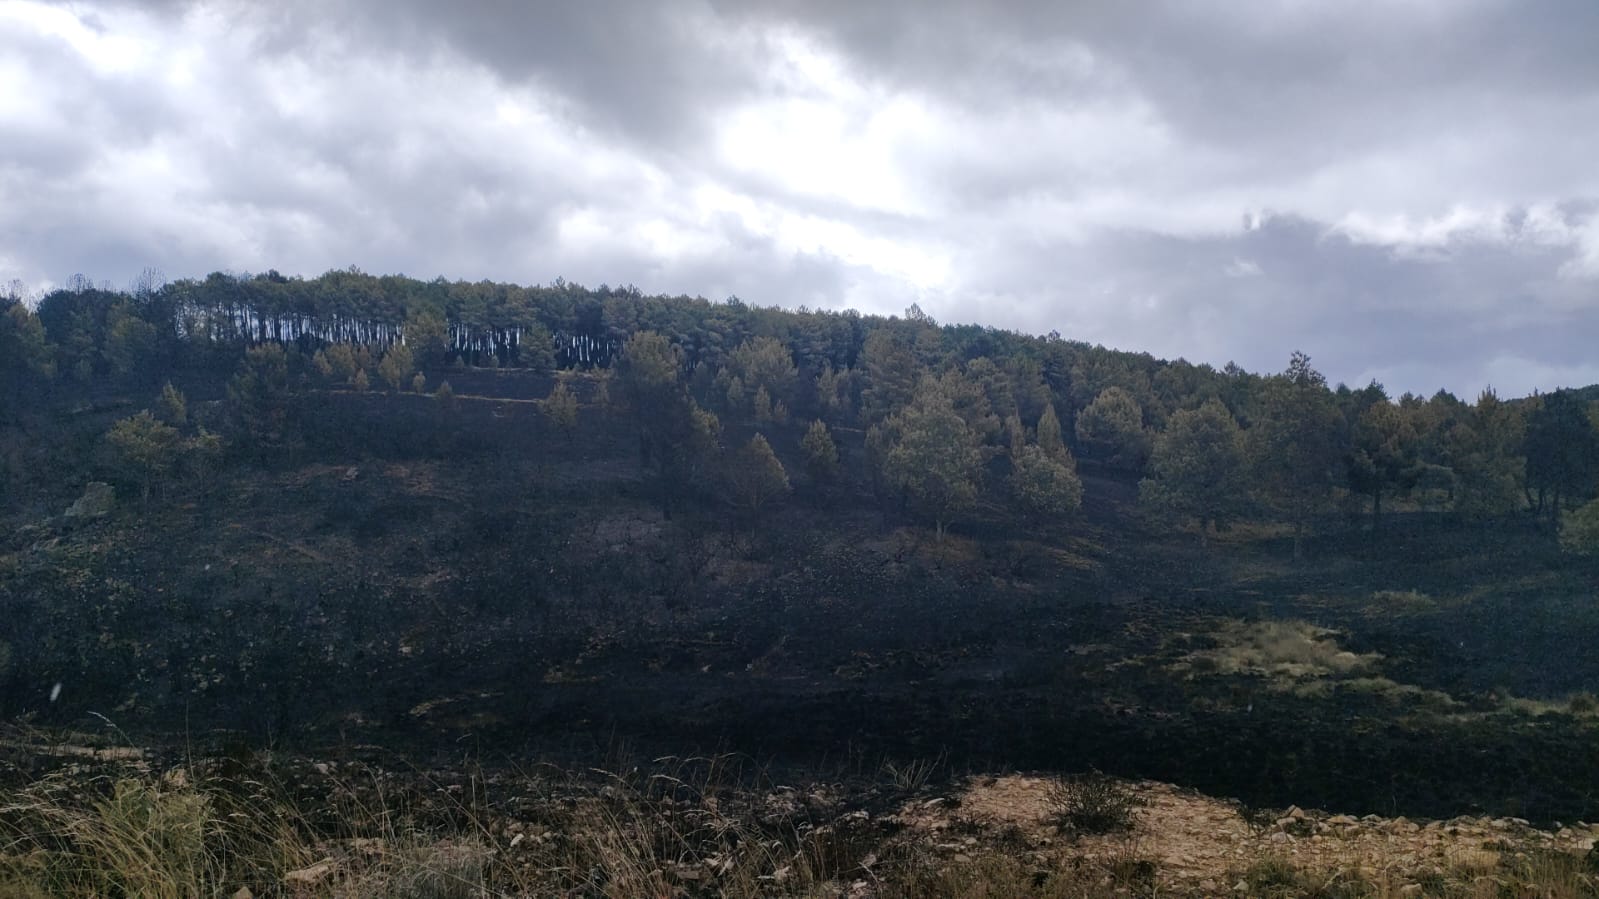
left=0, top=270, right=1599, bottom=819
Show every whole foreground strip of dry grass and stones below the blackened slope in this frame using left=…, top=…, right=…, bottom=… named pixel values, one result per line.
left=0, top=741, right=1599, bottom=899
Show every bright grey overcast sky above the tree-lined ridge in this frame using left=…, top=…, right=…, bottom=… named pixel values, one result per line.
left=0, top=0, right=1599, bottom=398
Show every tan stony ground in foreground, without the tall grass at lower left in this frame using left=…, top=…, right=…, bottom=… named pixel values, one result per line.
left=0, top=733, right=1599, bottom=899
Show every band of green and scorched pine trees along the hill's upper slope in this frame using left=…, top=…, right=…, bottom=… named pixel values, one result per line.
left=0, top=270, right=1599, bottom=537
